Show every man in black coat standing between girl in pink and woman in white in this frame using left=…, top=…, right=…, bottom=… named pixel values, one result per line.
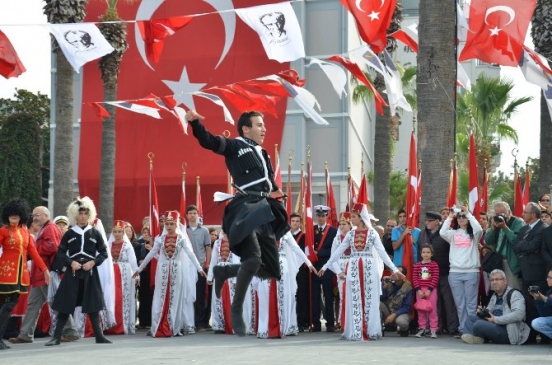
left=418, top=212, right=460, bottom=337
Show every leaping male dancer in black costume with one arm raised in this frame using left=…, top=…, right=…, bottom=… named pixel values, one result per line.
left=186, top=110, right=290, bottom=336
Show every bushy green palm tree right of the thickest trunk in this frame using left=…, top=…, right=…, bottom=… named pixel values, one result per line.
left=456, top=76, right=532, bottom=185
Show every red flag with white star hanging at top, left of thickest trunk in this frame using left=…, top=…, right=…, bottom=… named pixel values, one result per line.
left=341, top=0, right=397, bottom=53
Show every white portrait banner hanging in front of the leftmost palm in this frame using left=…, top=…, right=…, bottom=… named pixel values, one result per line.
left=44, top=23, right=115, bottom=73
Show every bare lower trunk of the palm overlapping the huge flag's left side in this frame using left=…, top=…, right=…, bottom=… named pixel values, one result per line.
left=99, top=76, right=117, bottom=224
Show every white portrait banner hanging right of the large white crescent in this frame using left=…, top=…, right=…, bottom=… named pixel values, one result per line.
left=236, top=2, right=305, bottom=63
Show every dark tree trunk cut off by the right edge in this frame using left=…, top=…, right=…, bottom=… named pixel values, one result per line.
left=539, top=93, right=552, bottom=196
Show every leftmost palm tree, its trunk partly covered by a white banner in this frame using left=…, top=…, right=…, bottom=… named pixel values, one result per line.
left=43, top=0, right=88, bottom=215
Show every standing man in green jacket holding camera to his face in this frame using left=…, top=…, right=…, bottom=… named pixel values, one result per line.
left=485, top=202, right=524, bottom=290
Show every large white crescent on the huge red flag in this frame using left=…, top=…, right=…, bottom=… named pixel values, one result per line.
left=134, top=0, right=237, bottom=70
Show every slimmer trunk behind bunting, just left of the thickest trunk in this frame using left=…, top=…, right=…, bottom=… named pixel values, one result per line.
left=374, top=88, right=391, bottom=219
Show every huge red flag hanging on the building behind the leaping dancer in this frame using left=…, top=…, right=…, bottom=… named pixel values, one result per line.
left=78, top=0, right=289, bottom=227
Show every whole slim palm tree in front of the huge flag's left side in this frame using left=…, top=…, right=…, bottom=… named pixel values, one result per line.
left=99, top=0, right=128, bottom=222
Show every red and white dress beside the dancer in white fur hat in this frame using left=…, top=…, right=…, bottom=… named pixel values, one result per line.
left=105, top=240, right=138, bottom=335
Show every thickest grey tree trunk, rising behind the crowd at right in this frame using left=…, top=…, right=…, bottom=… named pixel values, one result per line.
left=416, top=0, right=456, bottom=214
